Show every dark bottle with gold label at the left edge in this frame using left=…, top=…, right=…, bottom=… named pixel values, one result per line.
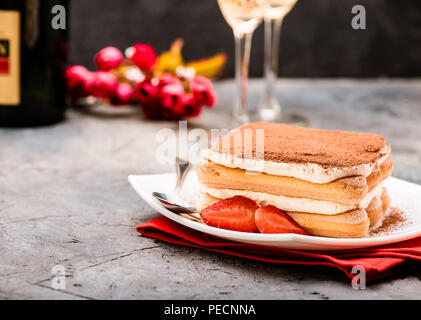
left=0, top=0, right=68, bottom=127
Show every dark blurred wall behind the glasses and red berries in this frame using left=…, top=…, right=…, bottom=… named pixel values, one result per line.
left=70, top=0, right=421, bottom=77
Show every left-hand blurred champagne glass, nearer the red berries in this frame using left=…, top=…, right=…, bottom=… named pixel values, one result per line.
left=218, top=0, right=265, bottom=127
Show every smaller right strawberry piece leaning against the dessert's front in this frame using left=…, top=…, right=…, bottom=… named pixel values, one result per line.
left=254, top=205, right=308, bottom=235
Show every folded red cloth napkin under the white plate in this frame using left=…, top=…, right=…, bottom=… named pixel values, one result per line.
left=136, top=217, right=421, bottom=281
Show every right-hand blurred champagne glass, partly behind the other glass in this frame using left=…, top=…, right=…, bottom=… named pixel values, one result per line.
left=258, top=0, right=306, bottom=124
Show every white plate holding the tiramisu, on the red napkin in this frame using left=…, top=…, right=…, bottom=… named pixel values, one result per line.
left=129, top=172, right=421, bottom=251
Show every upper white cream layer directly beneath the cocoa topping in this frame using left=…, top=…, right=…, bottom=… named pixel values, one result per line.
left=202, top=145, right=390, bottom=183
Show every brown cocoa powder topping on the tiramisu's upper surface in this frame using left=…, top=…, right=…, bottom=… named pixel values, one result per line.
left=212, top=122, right=388, bottom=168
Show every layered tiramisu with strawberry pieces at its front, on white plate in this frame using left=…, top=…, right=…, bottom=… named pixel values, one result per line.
left=197, top=122, right=393, bottom=238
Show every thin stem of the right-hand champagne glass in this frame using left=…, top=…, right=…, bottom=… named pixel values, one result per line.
left=263, top=18, right=283, bottom=106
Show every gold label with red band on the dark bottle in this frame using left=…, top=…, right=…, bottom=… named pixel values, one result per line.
left=0, top=10, right=20, bottom=106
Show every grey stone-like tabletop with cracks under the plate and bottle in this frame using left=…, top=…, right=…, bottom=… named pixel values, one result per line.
left=0, top=79, right=421, bottom=299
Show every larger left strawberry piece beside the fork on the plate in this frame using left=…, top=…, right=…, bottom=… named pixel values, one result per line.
left=200, top=196, right=259, bottom=232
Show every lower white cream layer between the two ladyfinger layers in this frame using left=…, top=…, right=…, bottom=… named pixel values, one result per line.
left=203, top=184, right=383, bottom=215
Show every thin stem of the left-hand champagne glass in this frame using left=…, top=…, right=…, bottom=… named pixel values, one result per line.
left=233, top=32, right=252, bottom=124
